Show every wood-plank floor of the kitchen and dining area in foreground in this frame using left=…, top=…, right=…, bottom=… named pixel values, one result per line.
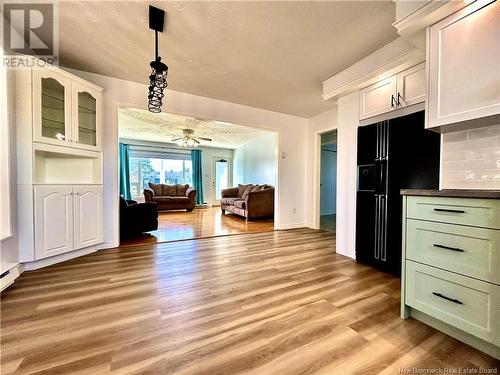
left=1, top=229, right=499, bottom=375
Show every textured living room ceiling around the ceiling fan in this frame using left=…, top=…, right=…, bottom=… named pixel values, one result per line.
left=118, top=107, right=272, bottom=148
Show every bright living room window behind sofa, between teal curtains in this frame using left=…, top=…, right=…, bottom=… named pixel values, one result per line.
left=129, top=156, right=193, bottom=198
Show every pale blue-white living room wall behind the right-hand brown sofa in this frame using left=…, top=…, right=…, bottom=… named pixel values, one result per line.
left=233, top=133, right=278, bottom=186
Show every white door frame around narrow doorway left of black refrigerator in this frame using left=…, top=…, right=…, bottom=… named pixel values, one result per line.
left=312, top=131, right=339, bottom=232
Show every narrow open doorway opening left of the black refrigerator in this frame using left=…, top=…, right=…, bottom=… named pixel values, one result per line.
left=319, top=130, right=337, bottom=233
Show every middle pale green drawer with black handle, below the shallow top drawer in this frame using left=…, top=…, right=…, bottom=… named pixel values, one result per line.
left=406, top=219, right=500, bottom=284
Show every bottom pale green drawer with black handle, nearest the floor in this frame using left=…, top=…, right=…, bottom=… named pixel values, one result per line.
left=405, top=260, right=500, bottom=345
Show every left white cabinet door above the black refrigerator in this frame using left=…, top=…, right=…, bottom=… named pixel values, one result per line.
left=359, top=76, right=397, bottom=120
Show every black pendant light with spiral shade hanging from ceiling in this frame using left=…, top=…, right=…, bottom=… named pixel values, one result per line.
left=148, top=5, right=168, bottom=113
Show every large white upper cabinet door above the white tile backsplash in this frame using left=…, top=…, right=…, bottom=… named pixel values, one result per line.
left=427, top=1, right=500, bottom=128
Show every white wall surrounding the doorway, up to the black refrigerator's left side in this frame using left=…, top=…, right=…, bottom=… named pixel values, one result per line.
left=307, top=92, right=359, bottom=258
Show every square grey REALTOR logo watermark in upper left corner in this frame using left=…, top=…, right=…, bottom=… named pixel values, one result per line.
left=1, top=1, right=59, bottom=69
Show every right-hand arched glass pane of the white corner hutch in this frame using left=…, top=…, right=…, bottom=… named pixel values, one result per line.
left=77, top=91, right=97, bottom=147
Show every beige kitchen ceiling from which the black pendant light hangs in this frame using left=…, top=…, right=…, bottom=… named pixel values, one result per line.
left=59, top=1, right=397, bottom=117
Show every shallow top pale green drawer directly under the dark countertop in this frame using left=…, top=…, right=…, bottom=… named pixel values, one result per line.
left=407, top=197, right=500, bottom=229
